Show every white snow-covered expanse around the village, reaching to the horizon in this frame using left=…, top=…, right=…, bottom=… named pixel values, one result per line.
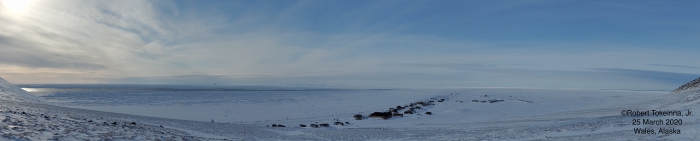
left=0, top=78, right=700, bottom=140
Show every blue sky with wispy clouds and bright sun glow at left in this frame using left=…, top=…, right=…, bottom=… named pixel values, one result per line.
left=0, top=0, right=700, bottom=90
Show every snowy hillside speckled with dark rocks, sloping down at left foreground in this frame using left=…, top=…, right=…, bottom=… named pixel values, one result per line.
left=0, top=78, right=227, bottom=141
